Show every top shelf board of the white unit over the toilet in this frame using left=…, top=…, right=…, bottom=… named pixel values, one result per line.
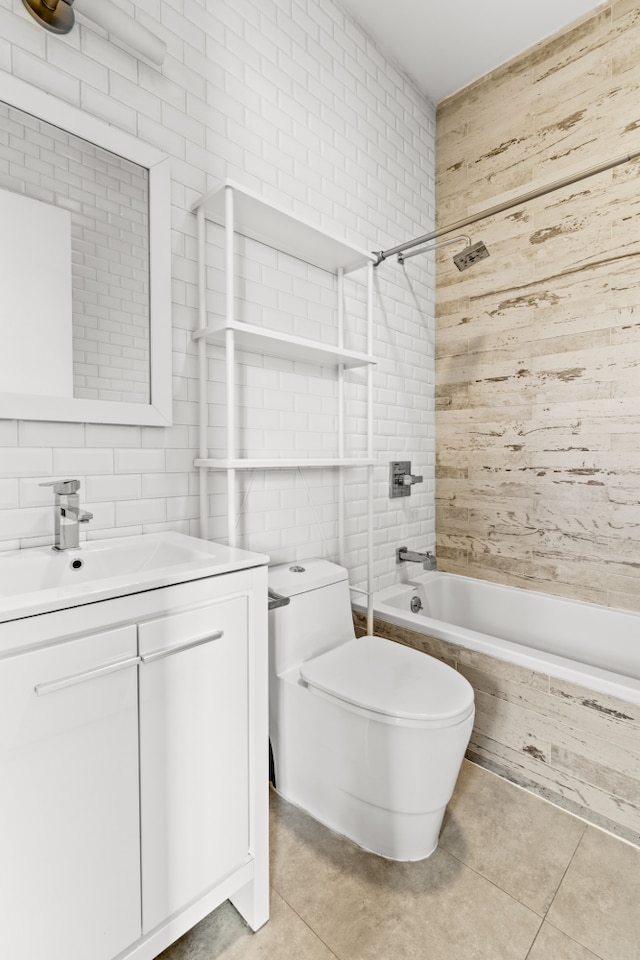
left=192, top=180, right=375, bottom=273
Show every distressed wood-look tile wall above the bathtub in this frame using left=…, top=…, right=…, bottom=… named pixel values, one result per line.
left=436, top=0, right=640, bottom=612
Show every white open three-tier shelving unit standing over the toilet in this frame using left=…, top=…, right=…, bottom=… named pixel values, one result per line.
left=192, top=180, right=376, bottom=632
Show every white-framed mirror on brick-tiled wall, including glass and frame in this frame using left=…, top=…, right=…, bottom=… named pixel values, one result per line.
left=0, top=71, right=172, bottom=426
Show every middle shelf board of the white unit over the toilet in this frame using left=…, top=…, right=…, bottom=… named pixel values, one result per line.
left=193, top=320, right=376, bottom=368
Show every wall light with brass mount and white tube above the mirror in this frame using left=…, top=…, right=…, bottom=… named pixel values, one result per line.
left=22, top=0, right=167, bottom=66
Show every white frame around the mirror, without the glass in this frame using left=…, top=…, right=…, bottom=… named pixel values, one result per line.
left=0, top=71, right=172, bottom=426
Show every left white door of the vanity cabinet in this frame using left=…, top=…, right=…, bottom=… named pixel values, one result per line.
left=0, top=627, right=141, bottom=960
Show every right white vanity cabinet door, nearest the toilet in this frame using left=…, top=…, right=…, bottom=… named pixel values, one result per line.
left=138, top=596, right=249, bottom=934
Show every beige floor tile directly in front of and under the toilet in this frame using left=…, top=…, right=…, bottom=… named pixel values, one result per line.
left=272, top=797, right=541, bottom=960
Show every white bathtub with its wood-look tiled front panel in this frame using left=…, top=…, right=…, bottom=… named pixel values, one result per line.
left=354, top=571, right=640, bottom=847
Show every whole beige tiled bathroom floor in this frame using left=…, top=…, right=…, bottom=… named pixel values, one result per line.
left=161, top=761, right=640, bottom=960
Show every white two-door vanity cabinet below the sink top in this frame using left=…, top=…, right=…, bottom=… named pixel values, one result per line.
left=0, top=551, right=269, bottom=960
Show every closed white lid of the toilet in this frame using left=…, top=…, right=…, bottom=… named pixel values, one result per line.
left=300, top=637, right=473, bottom=724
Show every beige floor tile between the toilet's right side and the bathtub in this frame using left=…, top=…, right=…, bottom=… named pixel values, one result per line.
left=440, top=761, right=586, bottom=917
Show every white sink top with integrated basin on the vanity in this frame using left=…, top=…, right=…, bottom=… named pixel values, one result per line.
left=0, top=533, right=268, bottom=622
